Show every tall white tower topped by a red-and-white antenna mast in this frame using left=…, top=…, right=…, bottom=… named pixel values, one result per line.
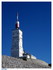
left=11, top=14, right=23, bottom=58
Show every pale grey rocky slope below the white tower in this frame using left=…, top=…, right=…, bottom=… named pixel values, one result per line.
left=2, top=55, right=50, bottom=68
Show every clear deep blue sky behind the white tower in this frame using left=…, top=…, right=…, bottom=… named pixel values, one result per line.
left=2, top=2, right=51, bottom=63
